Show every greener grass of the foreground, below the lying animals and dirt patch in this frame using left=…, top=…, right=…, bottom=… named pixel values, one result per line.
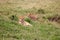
left=0, top=20, right=60, bottom=40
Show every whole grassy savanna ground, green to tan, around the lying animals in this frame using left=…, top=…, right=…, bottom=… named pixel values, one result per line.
left=0, top=0, right=60, bottom=40
